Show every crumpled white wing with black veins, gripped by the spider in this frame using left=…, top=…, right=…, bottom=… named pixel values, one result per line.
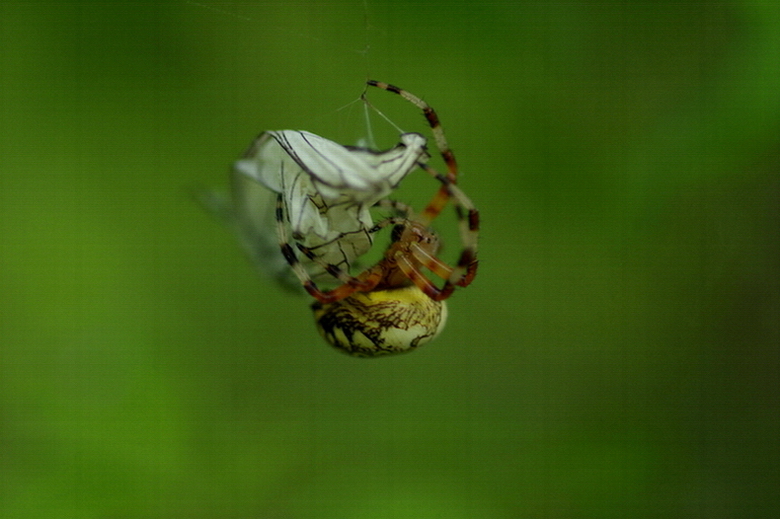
left=234, top=130, right=428, bottom=286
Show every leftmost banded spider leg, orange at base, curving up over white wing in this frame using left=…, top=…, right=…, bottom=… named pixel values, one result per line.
left=276, top=193, right=382, bottom=303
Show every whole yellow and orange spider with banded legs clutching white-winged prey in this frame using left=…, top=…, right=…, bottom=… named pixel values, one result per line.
left=275, top=80, right=479, bottom=357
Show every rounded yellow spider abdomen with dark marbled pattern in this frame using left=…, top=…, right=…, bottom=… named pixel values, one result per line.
left=312, top=285, right=447, bottom=357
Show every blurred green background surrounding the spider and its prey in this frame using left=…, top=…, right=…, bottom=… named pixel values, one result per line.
left=0, top=0, right=780, bottom=519
